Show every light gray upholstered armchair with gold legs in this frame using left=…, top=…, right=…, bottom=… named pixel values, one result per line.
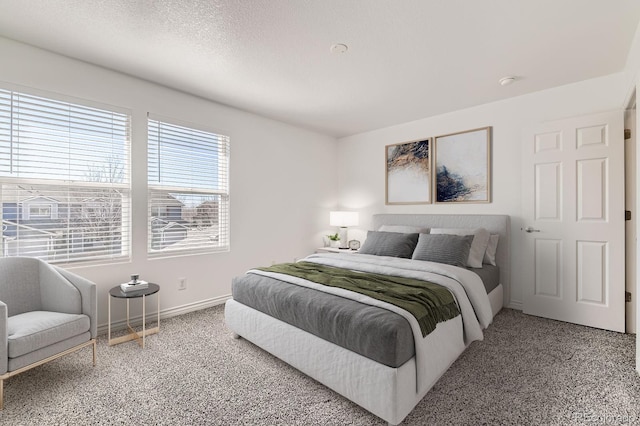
left=0, top=257, right=98, bottom=409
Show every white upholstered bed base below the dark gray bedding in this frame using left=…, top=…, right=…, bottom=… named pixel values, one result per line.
left=225, top=299, right=465, bottom=425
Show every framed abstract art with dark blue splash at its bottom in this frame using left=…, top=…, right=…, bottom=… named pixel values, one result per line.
left=433, top=127, right=491, bottom=203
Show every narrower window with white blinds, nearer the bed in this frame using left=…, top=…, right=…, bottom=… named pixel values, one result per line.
left=147, top=116, right=229, bottom=257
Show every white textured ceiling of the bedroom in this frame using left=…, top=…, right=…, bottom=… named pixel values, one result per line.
left=0, top=0, right=640, bottom=137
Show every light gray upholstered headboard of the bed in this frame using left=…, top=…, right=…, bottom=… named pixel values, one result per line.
left=373, top=214, right=511, bottom=289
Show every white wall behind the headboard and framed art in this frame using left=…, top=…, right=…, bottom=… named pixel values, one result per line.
left=338, top=73, right=629, bottom=309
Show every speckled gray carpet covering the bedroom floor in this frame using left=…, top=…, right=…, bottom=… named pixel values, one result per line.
left=0, top=306, right=640, bottom=425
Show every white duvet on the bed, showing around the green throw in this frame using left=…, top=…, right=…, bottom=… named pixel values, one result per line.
left=248, top=253, right=493, bottom=394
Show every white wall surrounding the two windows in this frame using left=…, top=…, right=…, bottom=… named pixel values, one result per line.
left=0, top=38, right=337, bottom=326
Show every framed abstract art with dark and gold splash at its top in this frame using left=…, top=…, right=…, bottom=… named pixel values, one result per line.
left=385, top=139, right=431, bottom=204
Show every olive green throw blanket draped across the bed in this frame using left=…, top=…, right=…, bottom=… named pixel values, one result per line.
left=257, top=262, right=460, bottom=337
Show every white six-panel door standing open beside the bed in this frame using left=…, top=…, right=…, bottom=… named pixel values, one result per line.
left=521, top=111, right=625, bottom=332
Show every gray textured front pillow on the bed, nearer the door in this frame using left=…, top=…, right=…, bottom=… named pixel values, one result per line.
left=411, top=234, right=473, bottom=268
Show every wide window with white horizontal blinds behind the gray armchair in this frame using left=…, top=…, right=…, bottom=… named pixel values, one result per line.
left=0, top=89, right=130, bottom=263
